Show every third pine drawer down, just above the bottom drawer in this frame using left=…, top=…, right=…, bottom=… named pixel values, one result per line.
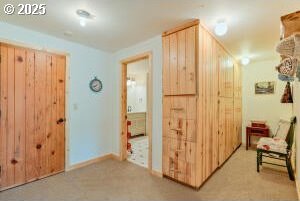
left=163, top=137, right=196, bottom=164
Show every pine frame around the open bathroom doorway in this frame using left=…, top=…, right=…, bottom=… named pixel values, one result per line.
left=120, top=51, right=153, bottom=172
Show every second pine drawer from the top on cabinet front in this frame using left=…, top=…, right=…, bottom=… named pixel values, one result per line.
left=163, top=118, right=196, bottom=142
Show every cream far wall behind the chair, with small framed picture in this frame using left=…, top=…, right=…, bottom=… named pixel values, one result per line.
left=242, top=59, right=293, bottom=143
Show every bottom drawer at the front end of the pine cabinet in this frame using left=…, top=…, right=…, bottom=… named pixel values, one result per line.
left=163, top=154, right=196, bottom=186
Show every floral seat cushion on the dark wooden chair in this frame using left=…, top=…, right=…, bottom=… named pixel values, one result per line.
left=257, top=137, right=287, bottom=154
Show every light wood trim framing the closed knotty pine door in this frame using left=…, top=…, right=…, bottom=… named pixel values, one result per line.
left=0, top=38, right=71, bottom=172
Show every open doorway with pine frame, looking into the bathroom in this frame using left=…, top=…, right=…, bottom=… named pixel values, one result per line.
left=120, top=53, right=152, bottom=170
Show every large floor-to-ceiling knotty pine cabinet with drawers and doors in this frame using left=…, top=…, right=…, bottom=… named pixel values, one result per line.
left=162, top=20, right=242, bottom=188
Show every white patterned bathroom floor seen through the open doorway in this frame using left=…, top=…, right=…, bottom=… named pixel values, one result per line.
left=127, top=136, right=149, bottom=167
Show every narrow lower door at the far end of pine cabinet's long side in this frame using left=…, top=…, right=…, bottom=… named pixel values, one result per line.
left=234, top=98, right=242, bottom=148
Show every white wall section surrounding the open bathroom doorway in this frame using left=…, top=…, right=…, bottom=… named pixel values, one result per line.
left=112, top=36, right=162, bottom=172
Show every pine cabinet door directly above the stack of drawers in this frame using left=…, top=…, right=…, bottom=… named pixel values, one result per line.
left=163, top=26, right=197, bottom=95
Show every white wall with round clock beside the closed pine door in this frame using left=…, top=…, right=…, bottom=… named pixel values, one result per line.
left=0, top=22, right=115, bottom=165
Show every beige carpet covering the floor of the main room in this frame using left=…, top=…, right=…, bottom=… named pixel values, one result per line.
left=0, top=147, right=297, bottom=201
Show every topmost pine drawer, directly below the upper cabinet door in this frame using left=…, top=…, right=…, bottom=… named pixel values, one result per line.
left=163, top=96, right=197, bottom=119
